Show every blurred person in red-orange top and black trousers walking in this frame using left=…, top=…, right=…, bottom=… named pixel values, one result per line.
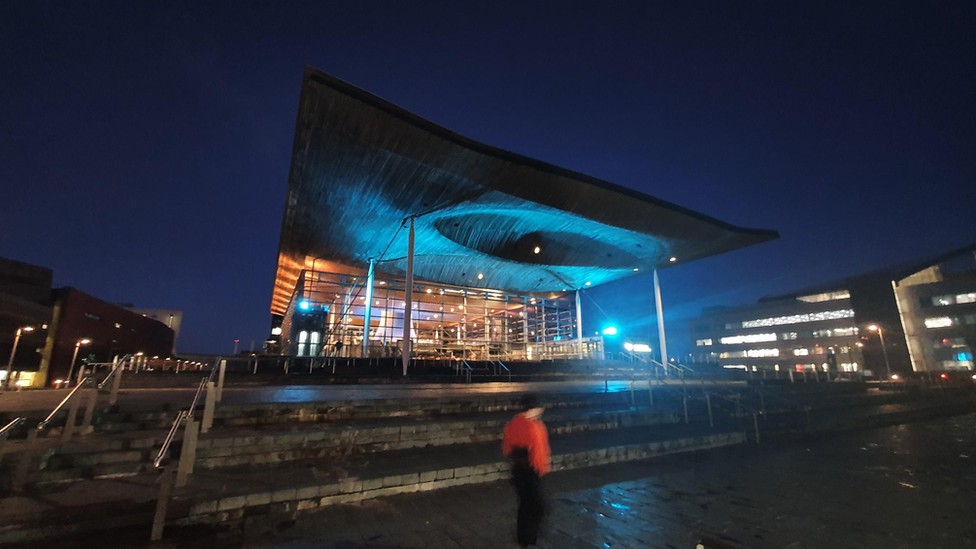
left=502, top=395, right=551, bottom=547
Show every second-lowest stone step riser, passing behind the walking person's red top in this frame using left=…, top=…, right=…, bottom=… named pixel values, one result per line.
left=19, top=402, right=679, bottom=483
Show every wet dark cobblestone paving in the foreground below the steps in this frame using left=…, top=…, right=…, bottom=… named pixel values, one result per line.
left=198, top=416, right=976, bottom=549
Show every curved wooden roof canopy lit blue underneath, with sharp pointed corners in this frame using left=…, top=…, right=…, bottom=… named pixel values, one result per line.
left=271, top=68, right=779, bottom=315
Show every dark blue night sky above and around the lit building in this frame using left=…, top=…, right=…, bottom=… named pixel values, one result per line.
left=0, top=0, right=976, bottom=355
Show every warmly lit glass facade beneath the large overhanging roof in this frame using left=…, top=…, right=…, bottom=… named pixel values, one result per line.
left=282, top=271, right=603, bottom=360
